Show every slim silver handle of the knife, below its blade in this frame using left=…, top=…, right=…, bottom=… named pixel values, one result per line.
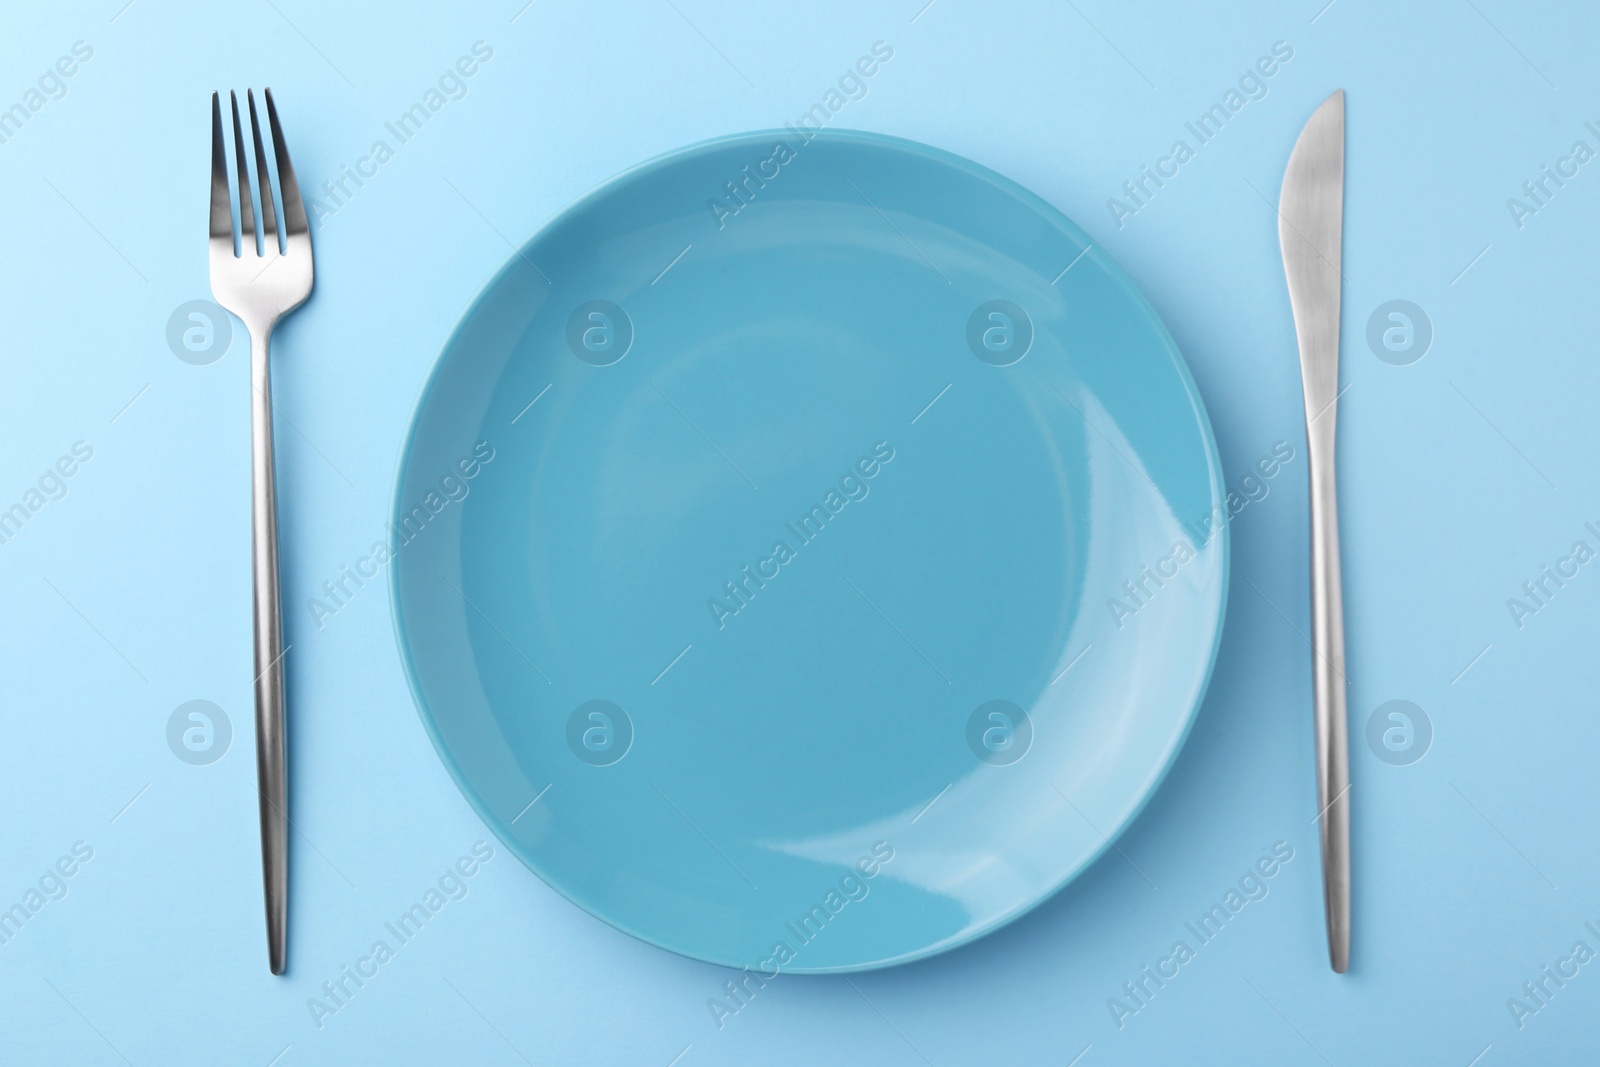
left=1306, top=412, right=1350, bottom=974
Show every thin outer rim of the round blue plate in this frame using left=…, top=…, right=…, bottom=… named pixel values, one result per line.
left=387, top=128, right=1234, bottom=976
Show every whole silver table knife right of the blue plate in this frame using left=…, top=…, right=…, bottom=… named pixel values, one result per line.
left=1278, top=90, right=1350, bottom=974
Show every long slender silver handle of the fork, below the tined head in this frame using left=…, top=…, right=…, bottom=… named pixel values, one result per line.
left=250, top=326, right=290, bottom=974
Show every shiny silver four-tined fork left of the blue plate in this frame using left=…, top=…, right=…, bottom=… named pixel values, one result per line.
left=211, top=90, right=312, bottom=974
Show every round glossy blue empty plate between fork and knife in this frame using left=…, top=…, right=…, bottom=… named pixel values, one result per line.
left=392, top=130, right=1227, bottom=974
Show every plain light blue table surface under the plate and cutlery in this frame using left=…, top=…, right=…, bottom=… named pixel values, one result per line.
left=0, top=0, right=1600, bottom=1067
